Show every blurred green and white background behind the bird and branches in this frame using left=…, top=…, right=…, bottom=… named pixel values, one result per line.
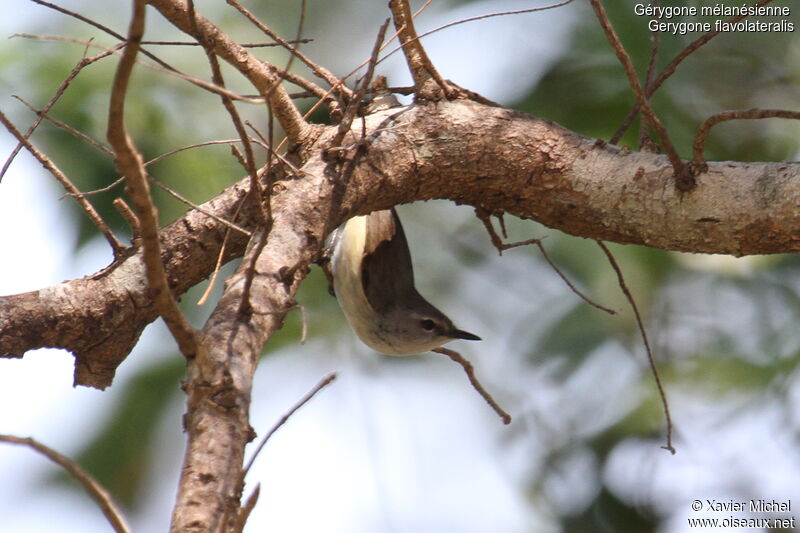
left=0, top=0, right=800, bottom=533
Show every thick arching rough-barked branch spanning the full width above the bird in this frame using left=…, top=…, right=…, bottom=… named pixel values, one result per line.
left=0, top=100, right=800, bottom=387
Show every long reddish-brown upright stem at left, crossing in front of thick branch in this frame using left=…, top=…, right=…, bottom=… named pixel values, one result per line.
left=107, top=0, right=198, bottom=357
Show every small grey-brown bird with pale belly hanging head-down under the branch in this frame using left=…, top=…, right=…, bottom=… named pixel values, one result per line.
left=331, top=209, right=481, bottom=355
